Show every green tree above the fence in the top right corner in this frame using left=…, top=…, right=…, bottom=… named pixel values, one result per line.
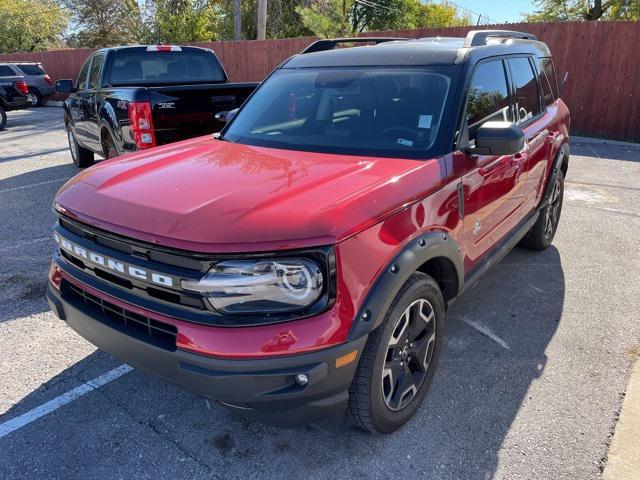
left=525, top=0, right=640, bottom=22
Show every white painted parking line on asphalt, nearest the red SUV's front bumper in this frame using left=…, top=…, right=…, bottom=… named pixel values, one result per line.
left=0, top=363, right=133, bottom=438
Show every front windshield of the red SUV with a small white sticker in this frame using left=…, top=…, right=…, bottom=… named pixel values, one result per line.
left=223, top=67, right=453, bottom=158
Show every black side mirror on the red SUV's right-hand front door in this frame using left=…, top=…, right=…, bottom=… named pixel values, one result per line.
left=465, top=122, right=524, bottom=155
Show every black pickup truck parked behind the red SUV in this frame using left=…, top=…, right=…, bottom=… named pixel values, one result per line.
left=55, top=45, right=258, bottom=168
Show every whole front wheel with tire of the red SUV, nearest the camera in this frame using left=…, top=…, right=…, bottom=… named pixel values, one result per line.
left=347, top=272, right=445, bottom=433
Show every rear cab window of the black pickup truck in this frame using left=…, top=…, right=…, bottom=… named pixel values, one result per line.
left=110, top=51, right=225, bottom=86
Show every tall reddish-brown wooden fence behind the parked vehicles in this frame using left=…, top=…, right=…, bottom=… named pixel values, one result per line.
left=0, top=22, right=640, bottom=141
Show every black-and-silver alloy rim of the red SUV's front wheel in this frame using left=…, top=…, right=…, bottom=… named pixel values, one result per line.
left=382, top=299, right=436, bottom=411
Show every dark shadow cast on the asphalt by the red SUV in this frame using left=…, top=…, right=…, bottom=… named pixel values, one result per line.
left=0, top=247, right=565, bottom=479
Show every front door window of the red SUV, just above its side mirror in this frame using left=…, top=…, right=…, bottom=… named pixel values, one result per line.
left=466, top=60, right=512, bottom=138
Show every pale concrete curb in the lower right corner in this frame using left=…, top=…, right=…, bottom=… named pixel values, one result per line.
left=602, top=361, right=640, bottom=480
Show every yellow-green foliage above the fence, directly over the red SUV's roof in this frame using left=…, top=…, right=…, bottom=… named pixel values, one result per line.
left=296, top=0, right=471, bottom=37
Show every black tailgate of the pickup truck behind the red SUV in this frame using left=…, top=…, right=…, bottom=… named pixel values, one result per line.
left=149, top=83, right=258, bottom=145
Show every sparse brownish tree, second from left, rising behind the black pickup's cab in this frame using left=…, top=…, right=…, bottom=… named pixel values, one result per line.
left=64, top=0, right=144, bottom=48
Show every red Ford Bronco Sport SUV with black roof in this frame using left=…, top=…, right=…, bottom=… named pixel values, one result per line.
left=47, top=31, right=569, bottom=432
